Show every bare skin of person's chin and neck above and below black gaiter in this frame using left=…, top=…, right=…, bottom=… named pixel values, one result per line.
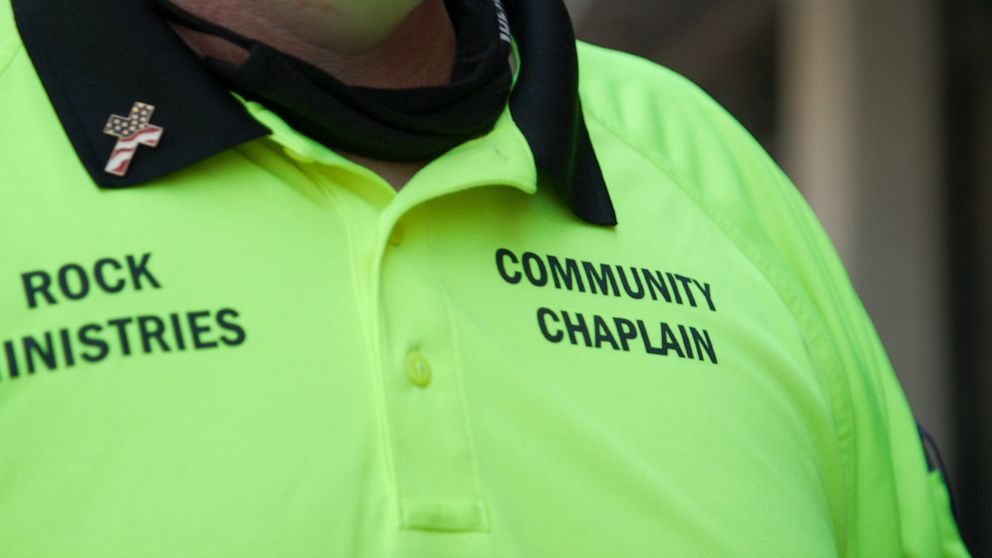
left=173, top=0, right=456, bottom=190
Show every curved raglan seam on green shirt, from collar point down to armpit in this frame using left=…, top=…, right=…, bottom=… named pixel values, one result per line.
left=584, top=105, right=857, bottom=540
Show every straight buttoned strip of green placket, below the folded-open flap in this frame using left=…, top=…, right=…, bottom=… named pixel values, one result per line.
left=377, top=212, right=489, bottom=532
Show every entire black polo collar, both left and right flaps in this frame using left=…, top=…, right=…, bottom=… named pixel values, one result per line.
left=12, top=0, right=616, bottom=225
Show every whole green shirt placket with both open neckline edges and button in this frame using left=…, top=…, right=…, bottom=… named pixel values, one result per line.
left=260, top=105, right=536, bottom=533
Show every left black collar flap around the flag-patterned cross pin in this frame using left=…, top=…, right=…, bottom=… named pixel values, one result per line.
left=13, top=0, right=269, bottom=188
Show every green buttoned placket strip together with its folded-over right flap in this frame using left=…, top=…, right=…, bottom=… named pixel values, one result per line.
left=362, top=115, right=536, bottom=533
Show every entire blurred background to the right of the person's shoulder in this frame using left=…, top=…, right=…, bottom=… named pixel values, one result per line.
left=567, top=0, right=992, bottom=557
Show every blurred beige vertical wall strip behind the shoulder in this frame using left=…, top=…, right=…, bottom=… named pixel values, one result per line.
left=780, top=0, right=956, bottom=470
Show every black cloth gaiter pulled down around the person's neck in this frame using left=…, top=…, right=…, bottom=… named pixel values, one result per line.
left=154, top=0, right=512, bottom=161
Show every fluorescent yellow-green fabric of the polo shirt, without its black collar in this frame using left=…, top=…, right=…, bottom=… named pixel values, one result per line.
left=0, top=3, right=967, bottom=558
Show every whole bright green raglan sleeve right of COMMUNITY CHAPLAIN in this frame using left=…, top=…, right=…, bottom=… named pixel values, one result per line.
left=581, top=46, right=968, bottom=558
